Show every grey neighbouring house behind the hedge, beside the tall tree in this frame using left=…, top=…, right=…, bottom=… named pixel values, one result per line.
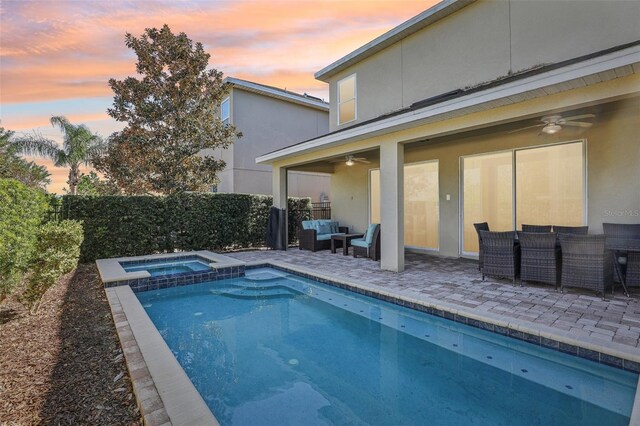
left=209, top=77, right=331, bottom=202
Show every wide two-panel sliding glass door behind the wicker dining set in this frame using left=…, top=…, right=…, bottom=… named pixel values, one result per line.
left=461, top=141, right=586, bottom=253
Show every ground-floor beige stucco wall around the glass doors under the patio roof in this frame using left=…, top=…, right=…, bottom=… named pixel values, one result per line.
left=331, top=98, right=640, bottom=256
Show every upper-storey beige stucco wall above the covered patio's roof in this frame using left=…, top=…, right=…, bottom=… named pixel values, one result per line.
left=329, top=0, right=640, bottom=130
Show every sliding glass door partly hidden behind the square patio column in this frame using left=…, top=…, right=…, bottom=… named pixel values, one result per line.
left=369, top=161, right=440, bottom=250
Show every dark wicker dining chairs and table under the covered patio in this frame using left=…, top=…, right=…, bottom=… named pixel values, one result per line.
left=474, top=222, right=640, bottom=299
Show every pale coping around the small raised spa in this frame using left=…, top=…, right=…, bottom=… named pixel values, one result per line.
left=96, top=250, right=244, bottom=284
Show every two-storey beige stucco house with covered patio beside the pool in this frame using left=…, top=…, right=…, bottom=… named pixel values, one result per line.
left=257, top=0, right=640, bottom=271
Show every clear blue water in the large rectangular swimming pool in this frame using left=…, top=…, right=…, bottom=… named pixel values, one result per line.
left=137, top=268, right=638, bottom=426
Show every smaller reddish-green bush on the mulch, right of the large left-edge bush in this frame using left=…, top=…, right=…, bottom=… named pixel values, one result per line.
left=21, top=220, right=83, bottom=313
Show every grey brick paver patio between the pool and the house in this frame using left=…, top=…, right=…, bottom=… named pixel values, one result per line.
left=230, top=248, right=640, bottom=358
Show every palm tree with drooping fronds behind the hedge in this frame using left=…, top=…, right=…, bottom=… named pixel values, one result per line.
left=12, top=116, right=105, bottom=195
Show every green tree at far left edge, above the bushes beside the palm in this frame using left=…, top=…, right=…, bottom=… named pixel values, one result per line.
left=0, top=127, right=51, bottom=189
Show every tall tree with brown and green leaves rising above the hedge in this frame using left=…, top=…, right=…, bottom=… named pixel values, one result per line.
left=95, top=25, right=241, bottom=194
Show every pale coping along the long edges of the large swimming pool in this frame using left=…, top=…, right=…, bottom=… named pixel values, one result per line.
left=105, top=258, right=640, bottom=425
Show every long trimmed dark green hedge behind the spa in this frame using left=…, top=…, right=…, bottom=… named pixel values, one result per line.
left=61, top=193, right=309, bottom=262
